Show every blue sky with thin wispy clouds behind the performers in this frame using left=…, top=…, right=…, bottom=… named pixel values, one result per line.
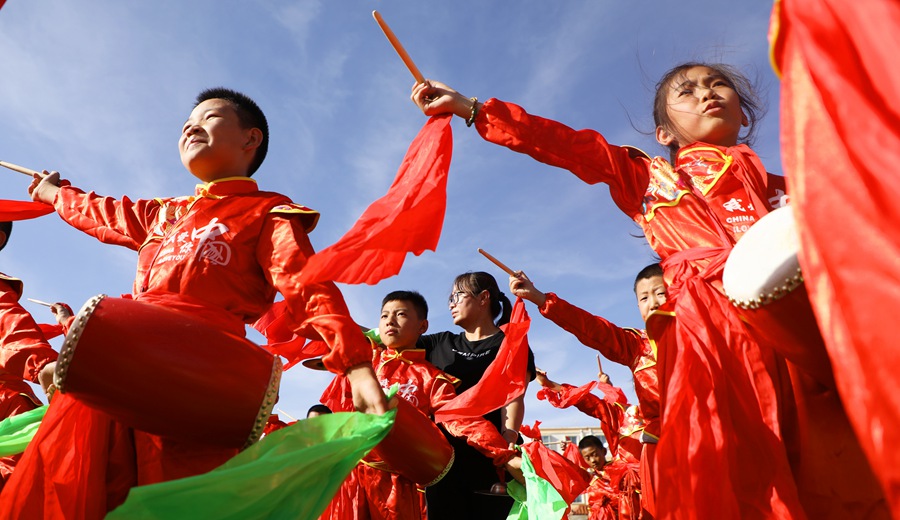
left=0, top=0, right=781, bottom=426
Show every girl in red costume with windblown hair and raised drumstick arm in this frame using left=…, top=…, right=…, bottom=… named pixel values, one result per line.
left=412, top=63, right=805, bottom=518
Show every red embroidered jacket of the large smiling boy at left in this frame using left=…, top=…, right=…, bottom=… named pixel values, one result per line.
left=54, top=177, right=370, bottom=372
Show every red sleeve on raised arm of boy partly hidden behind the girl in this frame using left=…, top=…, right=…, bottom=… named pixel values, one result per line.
left=539, top=293, right=644, bottom=369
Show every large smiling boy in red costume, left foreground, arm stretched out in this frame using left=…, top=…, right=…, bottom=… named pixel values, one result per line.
left=0, top=88, right=387, bottom=518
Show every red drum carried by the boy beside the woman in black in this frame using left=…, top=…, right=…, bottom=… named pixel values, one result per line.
left=365, top=398, right=454, bottom=487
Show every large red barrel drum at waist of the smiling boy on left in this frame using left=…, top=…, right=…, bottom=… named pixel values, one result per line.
left=54, top=295, right=281, bottom=448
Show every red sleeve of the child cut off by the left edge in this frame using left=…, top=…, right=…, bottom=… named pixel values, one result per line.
left=0, top=279, right=57, bottom=383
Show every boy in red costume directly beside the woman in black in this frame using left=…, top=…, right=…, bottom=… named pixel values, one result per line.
left=323, top=291, right=521, bottom=520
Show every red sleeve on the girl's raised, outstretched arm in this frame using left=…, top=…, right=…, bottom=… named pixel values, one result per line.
left=475, top=99, right=650, bottom=216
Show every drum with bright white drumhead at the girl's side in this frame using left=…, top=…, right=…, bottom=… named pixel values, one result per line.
left=722, top=206, right=834, bottom=388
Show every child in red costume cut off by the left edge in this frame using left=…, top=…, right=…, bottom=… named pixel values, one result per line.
left=0, top=222, right=56, bottom=489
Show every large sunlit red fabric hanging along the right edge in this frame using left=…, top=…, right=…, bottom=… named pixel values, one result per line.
left=771, top=0, right=900, bottom=518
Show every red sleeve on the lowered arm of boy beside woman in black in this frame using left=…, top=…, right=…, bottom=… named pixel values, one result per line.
left=431, top=378, right=516, bottom=467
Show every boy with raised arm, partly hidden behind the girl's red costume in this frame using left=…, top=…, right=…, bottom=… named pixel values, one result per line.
left=509, top=264, right=666, bottom=516
